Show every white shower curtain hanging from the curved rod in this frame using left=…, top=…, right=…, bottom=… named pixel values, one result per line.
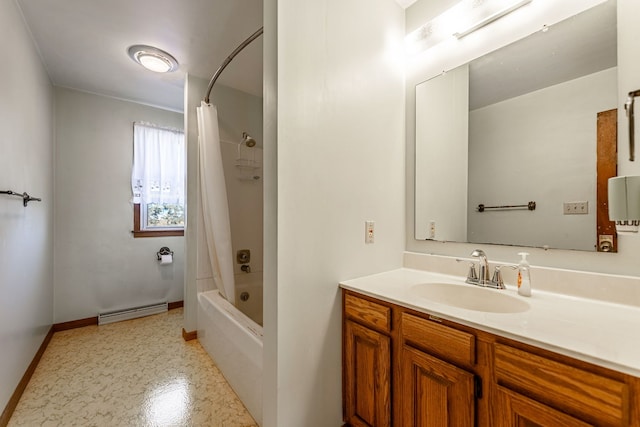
left=197, top=101, right=235, bottom=305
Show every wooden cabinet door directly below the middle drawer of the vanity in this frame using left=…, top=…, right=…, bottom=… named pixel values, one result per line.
left=401, top=345, right=475, bottom=427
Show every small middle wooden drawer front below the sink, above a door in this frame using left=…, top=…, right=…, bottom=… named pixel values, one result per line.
left=402, top=313, right=476, bottom=366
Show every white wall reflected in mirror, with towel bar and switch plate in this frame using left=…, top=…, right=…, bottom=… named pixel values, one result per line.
left=468, top=68, right=618, bottom=251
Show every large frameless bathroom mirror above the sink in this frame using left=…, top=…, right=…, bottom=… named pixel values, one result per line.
left=415, top=0, right=617, bottom=251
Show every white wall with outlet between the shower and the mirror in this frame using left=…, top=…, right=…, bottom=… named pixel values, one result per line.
left=272, top=0, right=404, bottom=427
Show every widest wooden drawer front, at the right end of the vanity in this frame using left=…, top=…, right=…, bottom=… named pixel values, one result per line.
left=494, top=343, right=629, bottom=426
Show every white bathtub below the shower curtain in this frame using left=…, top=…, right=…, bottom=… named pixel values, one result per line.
left=198, top=290, right=262, bottom=425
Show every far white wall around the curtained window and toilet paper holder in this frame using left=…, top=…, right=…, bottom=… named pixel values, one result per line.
left=54, top=88, right=184, bottom=323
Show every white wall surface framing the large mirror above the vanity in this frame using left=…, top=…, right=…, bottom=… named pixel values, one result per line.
left=406, top=0, right=640, bottom=276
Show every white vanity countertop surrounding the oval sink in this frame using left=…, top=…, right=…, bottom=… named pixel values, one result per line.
left=340, top=268, right=640, bottom=377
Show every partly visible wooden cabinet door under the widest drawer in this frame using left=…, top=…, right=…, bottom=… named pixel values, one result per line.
left=496, top=386, right=592, bottom=427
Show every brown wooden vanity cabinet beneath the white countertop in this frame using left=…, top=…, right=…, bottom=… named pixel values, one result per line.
left=343, top=290, right=640, bottom=427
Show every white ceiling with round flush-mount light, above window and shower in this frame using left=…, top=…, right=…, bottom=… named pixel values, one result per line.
left=15, top=0, right=262, bottom=111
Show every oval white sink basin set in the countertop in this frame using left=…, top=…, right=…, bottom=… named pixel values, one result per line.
left=411, top=283, right=529, bottom=313
